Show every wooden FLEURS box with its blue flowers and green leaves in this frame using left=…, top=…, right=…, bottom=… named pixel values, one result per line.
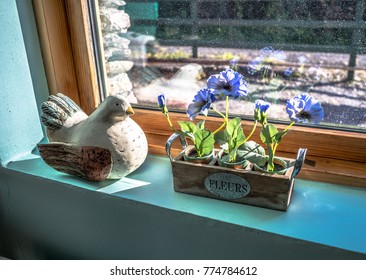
left=158, top=64, right=324, bottom=210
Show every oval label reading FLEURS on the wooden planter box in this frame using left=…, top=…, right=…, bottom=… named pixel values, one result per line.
left=204, top=173, right=250, bottom=199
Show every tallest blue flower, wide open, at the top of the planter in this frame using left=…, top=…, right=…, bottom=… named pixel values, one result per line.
left=207, top=69, right=248, bottom=99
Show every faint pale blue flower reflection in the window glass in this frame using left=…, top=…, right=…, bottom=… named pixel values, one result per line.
left=248, top=47, right=286, bottom=75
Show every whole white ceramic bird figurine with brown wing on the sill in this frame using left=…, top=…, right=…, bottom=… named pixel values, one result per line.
left=38, top=93, right=148, bottom=181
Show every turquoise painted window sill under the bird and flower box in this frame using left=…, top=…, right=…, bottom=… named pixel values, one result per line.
left=2, top=152, right=366, bottom=258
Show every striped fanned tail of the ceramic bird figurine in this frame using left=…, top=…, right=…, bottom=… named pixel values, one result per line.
left=41, top=93, right=88, bottom=130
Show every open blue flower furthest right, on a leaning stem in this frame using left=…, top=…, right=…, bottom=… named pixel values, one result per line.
left=286, top=93, right=324, bottom=124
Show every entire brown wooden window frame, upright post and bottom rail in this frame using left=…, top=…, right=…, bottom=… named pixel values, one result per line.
left=33, top=0, right=366, bottom=187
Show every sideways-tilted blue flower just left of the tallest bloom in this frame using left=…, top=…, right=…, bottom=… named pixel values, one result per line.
left=187, top=88, right=215, bottom=120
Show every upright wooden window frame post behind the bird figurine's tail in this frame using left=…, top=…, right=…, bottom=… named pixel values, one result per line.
left=33, top=0, right=100, bottom=114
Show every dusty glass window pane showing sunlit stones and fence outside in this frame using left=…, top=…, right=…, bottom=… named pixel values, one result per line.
left=99, top=0, right=366, bottom=130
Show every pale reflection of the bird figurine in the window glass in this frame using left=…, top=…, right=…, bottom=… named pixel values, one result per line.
left=133, top=63, right=205, bottom=108
